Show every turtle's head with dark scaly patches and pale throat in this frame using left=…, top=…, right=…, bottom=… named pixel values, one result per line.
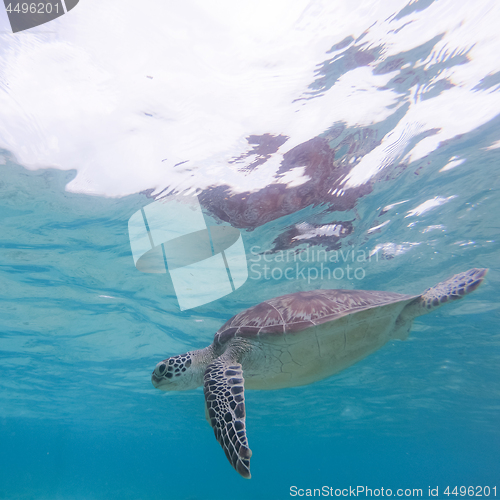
left=151, top=352, right=203, bottom=391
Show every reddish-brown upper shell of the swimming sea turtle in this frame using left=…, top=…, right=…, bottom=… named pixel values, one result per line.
left=214, top=290, right=419, bottom=345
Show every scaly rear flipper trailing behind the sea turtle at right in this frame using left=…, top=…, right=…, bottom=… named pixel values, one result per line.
left=407, top=268, right=488, bottom=317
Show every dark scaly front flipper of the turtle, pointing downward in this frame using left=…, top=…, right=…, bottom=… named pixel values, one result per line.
left=203, top=358, right=252, bottom=478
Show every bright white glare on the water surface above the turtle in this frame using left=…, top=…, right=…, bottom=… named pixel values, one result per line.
left=0, top=0, right=500, bottom=196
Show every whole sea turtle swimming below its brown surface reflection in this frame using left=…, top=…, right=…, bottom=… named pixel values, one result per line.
left=151, top=269, right=488, bottom=478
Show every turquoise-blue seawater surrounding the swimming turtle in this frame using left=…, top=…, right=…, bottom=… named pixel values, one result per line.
left=0, top=1, right=500, bottom=500
